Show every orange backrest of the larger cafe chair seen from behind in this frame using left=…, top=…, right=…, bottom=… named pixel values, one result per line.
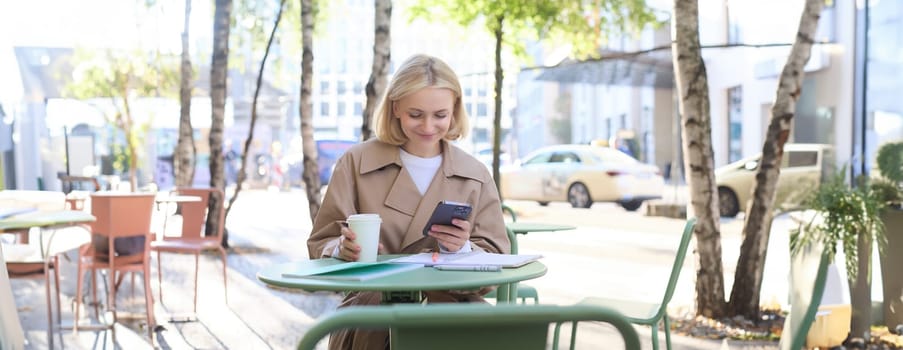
left=91, top=192, right=155, bottom=237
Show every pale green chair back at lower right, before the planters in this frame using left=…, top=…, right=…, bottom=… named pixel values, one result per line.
left=779, top=245, right=831, bottom=350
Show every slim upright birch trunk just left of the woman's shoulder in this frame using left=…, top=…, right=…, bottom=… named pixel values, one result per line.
left=300, top=0, right=320, bottom=222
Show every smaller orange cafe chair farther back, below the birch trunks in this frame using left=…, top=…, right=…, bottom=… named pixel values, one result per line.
left=150, top=188, right=228, bottom=314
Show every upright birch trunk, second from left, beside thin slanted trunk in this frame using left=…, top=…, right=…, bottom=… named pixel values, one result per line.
left=206, top=0, right=232, bottom=243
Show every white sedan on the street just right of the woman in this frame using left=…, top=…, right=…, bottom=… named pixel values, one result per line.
left=500, top=145, right=665, bottom=211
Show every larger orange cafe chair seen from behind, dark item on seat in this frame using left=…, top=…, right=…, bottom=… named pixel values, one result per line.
left=73, top=192, right=155, bottom=343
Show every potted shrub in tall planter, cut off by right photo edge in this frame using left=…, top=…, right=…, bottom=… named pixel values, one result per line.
left=872, top=141, right=903, bottom=333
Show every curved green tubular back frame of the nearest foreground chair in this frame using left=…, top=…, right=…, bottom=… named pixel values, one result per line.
left=298, top=304, right=640, bottom=350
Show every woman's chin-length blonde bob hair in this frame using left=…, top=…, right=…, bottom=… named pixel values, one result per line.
left=374, top=54, right=469, bottom=146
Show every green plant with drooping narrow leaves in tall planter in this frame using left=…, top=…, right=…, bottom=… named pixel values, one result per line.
left=790, top=171, right=885, bottom=339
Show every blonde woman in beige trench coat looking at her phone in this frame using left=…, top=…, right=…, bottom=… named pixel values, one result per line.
left=307, top=55, right=510, bottom=349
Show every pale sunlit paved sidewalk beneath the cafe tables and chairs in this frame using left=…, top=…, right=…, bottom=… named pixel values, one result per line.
left=12, top=191, right=775, bottom=349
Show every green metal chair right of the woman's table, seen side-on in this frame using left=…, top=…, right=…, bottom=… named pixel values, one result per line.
left=555, top=218, right=696, bottom=350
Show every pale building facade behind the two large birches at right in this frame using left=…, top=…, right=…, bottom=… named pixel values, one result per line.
left=518, top=0, right=903, bottom=180
